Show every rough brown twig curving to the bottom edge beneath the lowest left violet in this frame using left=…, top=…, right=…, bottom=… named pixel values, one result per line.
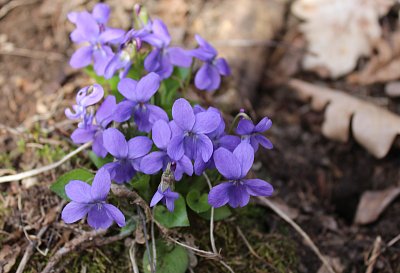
left=42, top=229, right=107, bottom=273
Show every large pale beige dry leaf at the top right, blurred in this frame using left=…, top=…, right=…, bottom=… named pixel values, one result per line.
left=292, top=0, right=395, bottom=77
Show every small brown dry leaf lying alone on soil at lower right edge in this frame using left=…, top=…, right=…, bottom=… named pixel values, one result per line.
left=354, top=187, right=400, bottom=225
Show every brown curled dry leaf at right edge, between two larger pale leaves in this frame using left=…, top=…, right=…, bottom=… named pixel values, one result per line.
left=347, top=31, right=400, bottom=85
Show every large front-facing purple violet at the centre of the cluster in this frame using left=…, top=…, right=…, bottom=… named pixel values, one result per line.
left=167, top=99, right=220, bottom=162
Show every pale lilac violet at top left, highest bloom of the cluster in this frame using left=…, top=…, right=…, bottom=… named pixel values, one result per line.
left=70, top=9, right=124, bottom=76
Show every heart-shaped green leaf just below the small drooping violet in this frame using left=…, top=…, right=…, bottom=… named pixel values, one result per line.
left=154, top=196, right=190, bottom=228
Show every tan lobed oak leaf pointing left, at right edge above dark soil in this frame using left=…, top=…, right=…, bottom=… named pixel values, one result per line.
left=289, top=79, right=400, bottom=158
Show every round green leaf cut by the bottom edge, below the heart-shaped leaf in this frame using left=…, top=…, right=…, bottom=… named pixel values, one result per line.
left=142, top=240, right=189, bottom=273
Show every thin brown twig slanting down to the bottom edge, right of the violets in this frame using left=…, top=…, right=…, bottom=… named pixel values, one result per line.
left=257, top=196, right=335, bottom=273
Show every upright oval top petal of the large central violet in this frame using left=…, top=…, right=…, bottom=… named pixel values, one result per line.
left=172, top=98, right=196, bottom=131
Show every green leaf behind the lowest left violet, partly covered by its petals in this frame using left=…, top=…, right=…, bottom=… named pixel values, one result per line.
left=50, top=169, right=94, bottom=200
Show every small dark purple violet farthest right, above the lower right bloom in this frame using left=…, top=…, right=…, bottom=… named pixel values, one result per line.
left=236, top=117, right=273, bottom=152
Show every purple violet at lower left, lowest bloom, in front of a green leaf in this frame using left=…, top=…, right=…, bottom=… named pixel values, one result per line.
left=61, top=170, right=125, bottom=229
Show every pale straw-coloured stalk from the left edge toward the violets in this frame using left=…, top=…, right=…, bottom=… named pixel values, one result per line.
left=0, top=142, right=92, bottom=183
